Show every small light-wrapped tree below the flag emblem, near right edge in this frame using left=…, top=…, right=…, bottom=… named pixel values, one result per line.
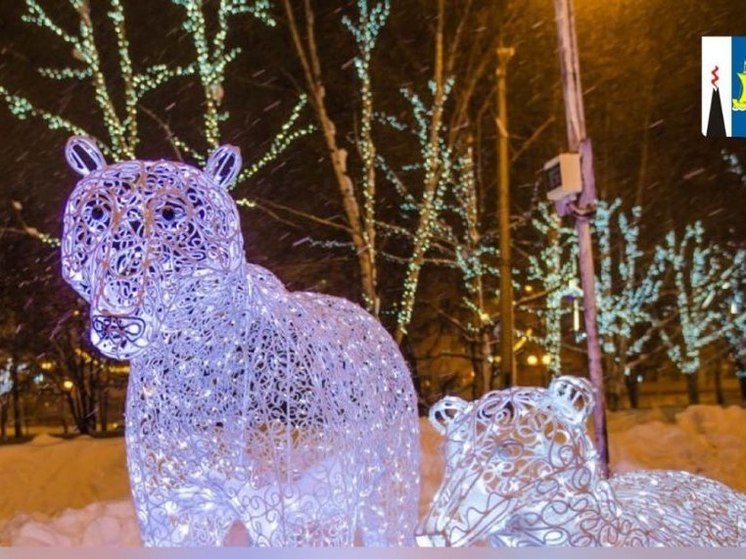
left=655, top=222, right=733, bottom=403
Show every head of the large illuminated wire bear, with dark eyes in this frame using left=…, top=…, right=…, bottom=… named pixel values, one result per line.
left=62, top=136, right=244, bottom=359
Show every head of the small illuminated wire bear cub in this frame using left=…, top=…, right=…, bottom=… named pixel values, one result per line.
left=417, top=376, right=596, bottom=546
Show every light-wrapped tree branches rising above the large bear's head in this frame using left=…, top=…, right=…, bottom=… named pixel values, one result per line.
left=0, top=0, right=311, bottom=180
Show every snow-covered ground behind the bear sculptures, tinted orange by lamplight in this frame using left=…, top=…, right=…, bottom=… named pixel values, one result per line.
left=0, top=405, right=746, bottom=546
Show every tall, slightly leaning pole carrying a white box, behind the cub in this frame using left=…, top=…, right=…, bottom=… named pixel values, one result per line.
left=554, top=0, right=609, bottom=477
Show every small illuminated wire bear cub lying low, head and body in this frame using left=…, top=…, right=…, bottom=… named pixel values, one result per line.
left=417, top=376, right=746, bottom=547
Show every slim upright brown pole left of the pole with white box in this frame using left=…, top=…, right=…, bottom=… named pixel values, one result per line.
left=488, top=45, right=517, bottom=389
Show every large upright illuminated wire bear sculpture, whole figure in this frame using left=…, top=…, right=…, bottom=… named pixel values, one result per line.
left=62, top=137, right=419, bottom=546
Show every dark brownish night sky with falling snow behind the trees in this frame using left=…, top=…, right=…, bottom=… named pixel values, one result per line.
left=0, top=0, right=746, bottom=394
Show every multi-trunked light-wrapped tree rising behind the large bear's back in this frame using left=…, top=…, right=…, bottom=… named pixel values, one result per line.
left=283, top=0, right=502, bottom=343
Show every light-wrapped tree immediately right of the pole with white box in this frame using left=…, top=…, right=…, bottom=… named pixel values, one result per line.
left=594, top=198, right=665, bottom=407
